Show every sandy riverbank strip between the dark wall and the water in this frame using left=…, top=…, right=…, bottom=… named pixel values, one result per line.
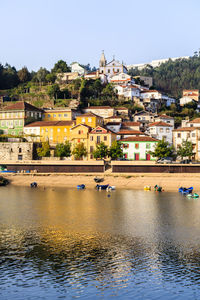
left=4, top=173, right=200, bottom=191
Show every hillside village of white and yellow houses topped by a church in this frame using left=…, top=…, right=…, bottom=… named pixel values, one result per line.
left=0, top=52, right=200, bottom=162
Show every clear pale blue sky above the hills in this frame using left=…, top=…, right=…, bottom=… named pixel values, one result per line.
left=0, top=0, right=200, bottom=71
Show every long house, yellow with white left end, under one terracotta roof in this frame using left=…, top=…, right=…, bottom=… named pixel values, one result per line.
left=24, top=121, right=75, bottom=145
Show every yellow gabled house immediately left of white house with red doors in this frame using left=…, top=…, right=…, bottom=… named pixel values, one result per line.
left=88, top=126, right=117, bottom=159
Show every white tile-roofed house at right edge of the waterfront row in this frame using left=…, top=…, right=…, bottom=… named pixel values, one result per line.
left=173, top=126, right=200, bottom=160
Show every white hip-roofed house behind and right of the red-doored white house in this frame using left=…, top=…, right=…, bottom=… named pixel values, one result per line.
left=148, top=121, right=173, bottom=145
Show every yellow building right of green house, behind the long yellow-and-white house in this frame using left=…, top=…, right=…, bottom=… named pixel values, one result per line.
left=43, top=108, right=75, bottom=121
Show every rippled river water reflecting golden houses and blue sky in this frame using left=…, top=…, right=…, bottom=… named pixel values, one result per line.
left=0, top=186, right=200, bottom=300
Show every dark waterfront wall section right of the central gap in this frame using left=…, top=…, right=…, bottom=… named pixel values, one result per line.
left=111, top=161, right=200, bottom=173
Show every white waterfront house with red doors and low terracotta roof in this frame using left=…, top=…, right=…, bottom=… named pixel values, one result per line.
left=120, top=136, right=158, bottom=161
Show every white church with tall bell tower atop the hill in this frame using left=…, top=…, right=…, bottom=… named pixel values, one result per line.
left=99, top=51, right=128, bottom=82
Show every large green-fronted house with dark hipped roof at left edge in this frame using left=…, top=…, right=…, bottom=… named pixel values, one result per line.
left=0, top=101, right=43, bottom=135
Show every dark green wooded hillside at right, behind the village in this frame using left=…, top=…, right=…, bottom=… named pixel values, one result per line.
left=129, top=53, right=200, bottom=98
